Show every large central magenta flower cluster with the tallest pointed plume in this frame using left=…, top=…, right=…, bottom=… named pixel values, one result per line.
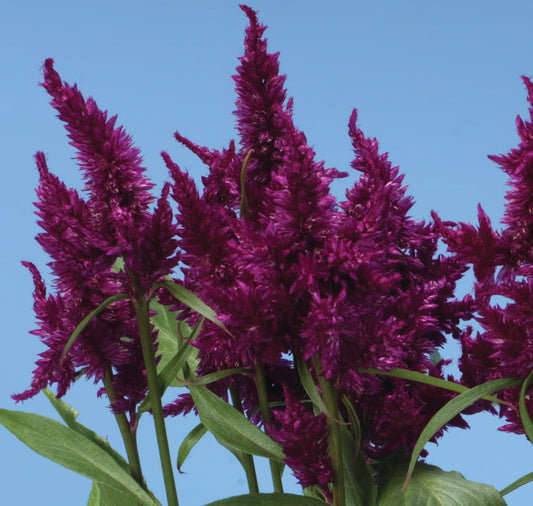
left=163, top=7, right=473, bottom=494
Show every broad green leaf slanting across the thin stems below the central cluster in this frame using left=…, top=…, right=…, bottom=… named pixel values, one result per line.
left=189, top=385, right=285, bottom=462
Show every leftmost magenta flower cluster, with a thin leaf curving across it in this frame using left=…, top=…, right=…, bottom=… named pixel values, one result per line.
left=13, top=59, right=178, bottom=423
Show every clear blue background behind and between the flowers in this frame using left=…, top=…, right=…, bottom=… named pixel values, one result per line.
left=0, top=0, right=533, bottom=506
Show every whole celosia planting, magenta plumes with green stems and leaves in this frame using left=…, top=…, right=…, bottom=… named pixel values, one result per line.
left=0, top=6, right=533, bottom=506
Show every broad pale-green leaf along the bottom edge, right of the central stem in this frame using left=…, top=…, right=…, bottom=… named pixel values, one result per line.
left=378, top=462, right=506, bottom=506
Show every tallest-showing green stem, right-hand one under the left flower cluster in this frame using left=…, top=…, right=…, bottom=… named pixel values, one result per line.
left=128, top=272, right=178, bottom=506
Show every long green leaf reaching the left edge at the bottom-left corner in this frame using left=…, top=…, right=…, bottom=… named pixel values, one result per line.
left=0, top=409, right=160, bottom=506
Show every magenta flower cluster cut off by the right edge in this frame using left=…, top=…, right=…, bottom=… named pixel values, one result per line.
left=446, top=77, right=533, bottom=433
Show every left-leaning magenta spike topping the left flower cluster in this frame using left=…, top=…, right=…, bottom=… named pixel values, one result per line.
left=43, top=59, right=153, bottom=255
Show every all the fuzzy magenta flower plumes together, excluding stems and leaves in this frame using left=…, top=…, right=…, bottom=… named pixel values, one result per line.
left=14, top=2, right=533, bottom=495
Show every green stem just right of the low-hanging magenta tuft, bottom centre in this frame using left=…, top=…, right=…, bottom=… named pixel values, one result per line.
left=313, top=355, right=346, bottom=506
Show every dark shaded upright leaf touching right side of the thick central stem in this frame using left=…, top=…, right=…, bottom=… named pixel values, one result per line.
left=340, top=426, right=376, bottom=506
